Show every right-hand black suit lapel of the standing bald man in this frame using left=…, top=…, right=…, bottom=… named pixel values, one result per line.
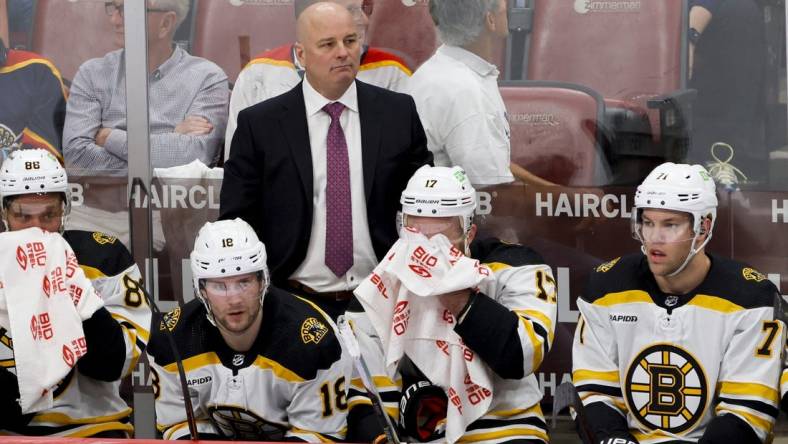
left=356, top=80, right=383, bottom=200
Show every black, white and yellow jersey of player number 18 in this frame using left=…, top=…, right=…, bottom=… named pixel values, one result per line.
left=148, top=287, right=352, bottom=442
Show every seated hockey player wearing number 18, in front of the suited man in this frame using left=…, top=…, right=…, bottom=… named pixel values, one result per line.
left=148, top=219, right=350, bottom=442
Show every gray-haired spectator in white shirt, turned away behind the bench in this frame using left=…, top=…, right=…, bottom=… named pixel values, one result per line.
left=409, top=0, right=551, bottom=185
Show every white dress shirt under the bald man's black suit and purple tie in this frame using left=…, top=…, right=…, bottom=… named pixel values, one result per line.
left=290, top=77, right=377, bottom=293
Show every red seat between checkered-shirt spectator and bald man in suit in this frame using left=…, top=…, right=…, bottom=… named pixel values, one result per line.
left=191, top=0, right=295, bottom=82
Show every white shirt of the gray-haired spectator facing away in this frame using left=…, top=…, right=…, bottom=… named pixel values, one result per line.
left=409, top=45, right=514, bottom=185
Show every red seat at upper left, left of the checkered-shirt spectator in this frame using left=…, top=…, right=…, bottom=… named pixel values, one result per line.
left=30, top=0, right=117, bottom=80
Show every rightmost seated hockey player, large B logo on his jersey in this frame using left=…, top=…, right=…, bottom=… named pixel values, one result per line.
left=572, top=163, right=784, bottom=444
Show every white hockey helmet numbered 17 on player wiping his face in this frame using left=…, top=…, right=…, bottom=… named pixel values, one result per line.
left=400, top=165, right=476, bottom=233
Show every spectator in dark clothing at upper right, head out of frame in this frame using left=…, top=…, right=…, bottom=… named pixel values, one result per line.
left=689, top=0, right=769, bottom=185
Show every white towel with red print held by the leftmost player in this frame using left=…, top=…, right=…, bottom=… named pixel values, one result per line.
left=0, top=228, right=104, bottom=413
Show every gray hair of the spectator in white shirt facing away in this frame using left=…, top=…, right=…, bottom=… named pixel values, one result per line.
left=429, top=0, right=501, bottom=46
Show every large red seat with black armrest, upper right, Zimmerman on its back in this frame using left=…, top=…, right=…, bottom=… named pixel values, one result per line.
left=525, top=0, right=694, bottom=184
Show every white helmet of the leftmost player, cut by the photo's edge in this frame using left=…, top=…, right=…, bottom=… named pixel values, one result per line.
left=0, top=148, right=71, bottom=232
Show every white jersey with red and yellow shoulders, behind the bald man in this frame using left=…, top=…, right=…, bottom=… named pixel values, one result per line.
left=224, top=44, right=412, bottom=154
